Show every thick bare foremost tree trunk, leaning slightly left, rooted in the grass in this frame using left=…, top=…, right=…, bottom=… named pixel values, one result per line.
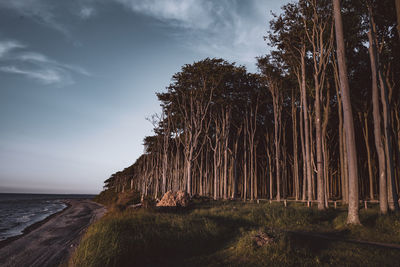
left=333, top=0, right=360, bottom=224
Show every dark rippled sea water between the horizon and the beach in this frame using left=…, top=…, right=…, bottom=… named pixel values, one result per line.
left=0, top=193, right=94, bottom=241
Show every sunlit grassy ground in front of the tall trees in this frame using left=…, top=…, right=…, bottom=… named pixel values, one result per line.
left=70, top=202, right=400, bottom=266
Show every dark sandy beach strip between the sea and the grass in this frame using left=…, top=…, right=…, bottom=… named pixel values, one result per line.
left=0, top=199, right=106, bottom=266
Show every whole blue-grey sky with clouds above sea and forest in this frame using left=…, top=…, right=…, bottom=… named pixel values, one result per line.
left=0, top=0, right=287, bottom=194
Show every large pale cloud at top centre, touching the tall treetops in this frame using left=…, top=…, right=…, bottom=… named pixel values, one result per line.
left=114, top=0, right=287, bottom=70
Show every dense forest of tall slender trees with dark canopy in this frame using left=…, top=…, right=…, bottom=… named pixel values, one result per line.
left=104, top=0, right=400, bottom=224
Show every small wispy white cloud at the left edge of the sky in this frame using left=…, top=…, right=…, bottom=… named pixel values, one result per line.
left=0, top=40, right=91, bottom=86
